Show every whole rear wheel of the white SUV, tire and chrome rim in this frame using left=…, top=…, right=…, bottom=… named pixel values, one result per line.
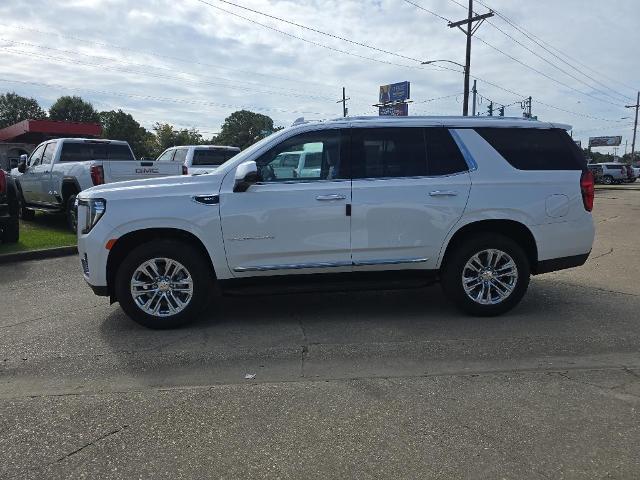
left=442, top=234, right=530, bottom=317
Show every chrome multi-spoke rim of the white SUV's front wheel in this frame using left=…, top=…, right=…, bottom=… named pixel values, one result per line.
left=131, top=258, right=193, bottom=317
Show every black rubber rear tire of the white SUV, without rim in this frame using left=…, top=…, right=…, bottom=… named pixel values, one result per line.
left=441, top=233, right=531, bottom=317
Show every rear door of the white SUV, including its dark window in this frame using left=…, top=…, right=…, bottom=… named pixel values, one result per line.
left=351, top=127, right=471, bottom=271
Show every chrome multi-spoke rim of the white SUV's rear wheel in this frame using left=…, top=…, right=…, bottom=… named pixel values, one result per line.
left=462, top=248, right=518, bottom=305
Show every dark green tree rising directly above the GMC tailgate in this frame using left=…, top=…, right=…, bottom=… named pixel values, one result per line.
left=100, top=110, right=157, bottom=158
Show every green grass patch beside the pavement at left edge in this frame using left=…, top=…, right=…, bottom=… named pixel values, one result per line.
left=0, top=213, right=77, bottom=255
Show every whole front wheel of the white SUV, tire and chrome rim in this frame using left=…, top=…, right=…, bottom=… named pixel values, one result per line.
left=115, top=240, right=213, bottom=329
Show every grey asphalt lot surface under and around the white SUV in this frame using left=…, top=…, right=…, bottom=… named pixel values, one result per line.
left=0, top=187, right=640, bottom=479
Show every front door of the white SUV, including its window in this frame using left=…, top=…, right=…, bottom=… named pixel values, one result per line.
left=220, top=130, right=351, bottom=277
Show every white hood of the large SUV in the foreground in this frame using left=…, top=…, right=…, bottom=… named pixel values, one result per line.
left=78, top=173, right=223, bottom=200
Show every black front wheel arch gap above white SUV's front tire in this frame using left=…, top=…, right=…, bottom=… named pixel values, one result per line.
left=106, top=227, right=216, bottom=302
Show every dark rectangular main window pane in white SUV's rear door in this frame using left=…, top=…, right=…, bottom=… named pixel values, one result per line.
left=351, top=128, right=427, bottom=178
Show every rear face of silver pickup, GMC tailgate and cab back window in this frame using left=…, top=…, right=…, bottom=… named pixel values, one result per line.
left=104, top=143, right=182, bottom=183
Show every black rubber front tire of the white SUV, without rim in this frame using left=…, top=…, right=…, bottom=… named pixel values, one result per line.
left=114, top=240, right=213, bottom=329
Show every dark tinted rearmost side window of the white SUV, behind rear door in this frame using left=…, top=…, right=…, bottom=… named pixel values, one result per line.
left=475, top=128, right=587, bottom=170
